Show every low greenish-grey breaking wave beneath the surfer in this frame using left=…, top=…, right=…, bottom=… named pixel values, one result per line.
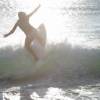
left=0, top=43, right=100, bottom=81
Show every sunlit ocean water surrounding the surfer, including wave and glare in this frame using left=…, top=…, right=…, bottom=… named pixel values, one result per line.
left=0, top=0, right=100, bottom=100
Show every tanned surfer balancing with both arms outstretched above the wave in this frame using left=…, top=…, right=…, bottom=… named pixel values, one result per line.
left=4, top=5, right=45, bottom=60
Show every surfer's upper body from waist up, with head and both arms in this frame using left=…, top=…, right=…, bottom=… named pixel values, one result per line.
left=4, top=5, right=40, bottom=37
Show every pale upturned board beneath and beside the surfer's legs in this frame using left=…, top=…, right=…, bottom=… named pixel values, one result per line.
left=31, top=24, right=47, bottom=59
